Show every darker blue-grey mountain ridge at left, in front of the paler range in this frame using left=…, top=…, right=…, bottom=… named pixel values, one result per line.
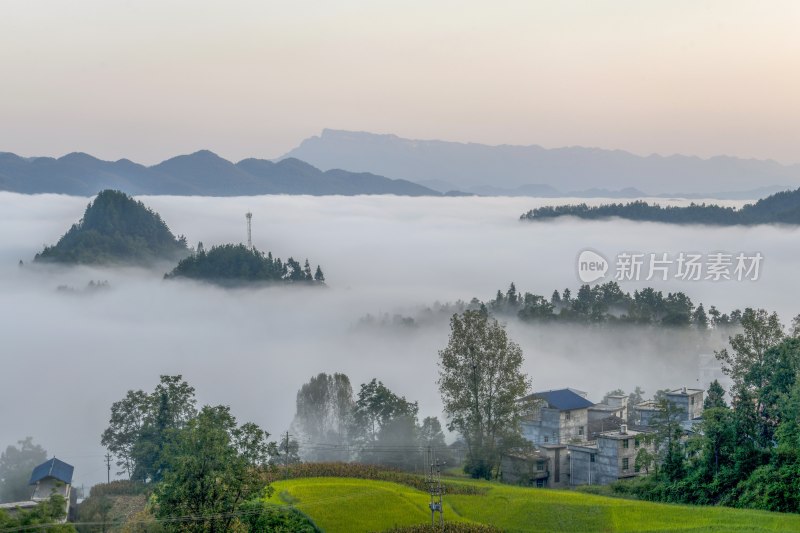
left=0, top=150, right=440, bottom=196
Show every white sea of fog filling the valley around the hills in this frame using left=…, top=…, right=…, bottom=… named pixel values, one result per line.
left=0, top=192, right=800, bottom=485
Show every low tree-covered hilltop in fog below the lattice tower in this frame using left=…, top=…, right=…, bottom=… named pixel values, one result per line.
left=164, top=243, right=325, bottom=286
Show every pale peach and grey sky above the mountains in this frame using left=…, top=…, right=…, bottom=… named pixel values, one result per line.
left=0, top=0, right=800, bottom=164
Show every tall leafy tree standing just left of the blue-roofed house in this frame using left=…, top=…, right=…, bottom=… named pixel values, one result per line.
left=438, top=311, right=530, bottom=478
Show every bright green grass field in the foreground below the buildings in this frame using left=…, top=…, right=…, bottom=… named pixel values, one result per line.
left=269, top=478, right=800, bottom=533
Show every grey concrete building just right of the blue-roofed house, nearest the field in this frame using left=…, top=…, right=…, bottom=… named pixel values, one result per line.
left=568, top=424, right=649, bottom=485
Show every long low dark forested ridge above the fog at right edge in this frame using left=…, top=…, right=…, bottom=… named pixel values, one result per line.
left=520, top=189, right=800, bottom=226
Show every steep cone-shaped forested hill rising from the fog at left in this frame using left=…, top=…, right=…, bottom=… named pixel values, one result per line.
left=34, top=190, right=189, bottom=264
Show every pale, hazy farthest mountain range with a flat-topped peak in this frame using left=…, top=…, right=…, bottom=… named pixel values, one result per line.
left=285, top=129, right=800, bottom=198
